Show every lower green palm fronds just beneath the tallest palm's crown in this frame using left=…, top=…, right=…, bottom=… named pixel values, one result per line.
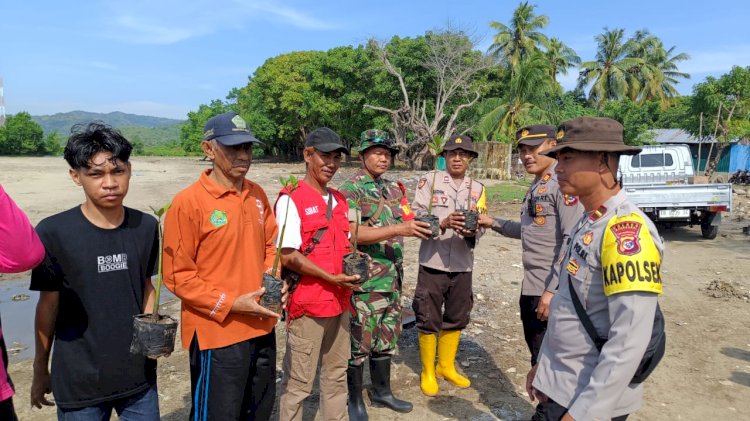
left=475, top=52, right=550, bottom=142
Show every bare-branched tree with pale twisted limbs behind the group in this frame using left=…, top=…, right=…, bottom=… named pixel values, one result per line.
left=365, top=30, right=494, bottom=168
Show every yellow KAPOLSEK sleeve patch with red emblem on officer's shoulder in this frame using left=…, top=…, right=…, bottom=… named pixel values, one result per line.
left=602, top=212, right=662, bottom=296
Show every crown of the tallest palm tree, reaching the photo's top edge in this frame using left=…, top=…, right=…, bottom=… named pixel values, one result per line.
left=488, top=2, right=549, bottom=68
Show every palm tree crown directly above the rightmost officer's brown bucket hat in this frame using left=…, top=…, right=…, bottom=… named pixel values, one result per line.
left=578, top=28, right=643, bottom=108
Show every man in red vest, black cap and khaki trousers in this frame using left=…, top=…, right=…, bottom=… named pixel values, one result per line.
left=276, top=127, right=359, bottom=420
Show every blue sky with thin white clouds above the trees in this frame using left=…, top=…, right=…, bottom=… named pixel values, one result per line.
left=0, top=0, right=750, bottom=119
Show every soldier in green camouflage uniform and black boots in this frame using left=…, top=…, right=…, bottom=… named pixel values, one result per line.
left=339, top=130, right=430, bottom=420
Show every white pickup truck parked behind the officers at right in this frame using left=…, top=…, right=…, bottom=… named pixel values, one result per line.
left=620, top=145, right=732, bottom=239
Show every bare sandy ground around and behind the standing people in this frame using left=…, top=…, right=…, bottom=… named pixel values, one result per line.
left=0, top=158, right=750, bottom=420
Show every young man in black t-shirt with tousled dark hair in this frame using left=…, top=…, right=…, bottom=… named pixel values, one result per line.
left=31, top=123, right=160, bottom=421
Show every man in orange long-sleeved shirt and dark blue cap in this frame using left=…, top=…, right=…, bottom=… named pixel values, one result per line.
left=163, top=112, right=280, bottom=420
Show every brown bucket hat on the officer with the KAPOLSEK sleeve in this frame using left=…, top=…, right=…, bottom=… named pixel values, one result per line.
left=542, top=117, right=641, bottom=157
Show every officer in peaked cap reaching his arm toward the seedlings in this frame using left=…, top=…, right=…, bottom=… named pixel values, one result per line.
left=480, top=124, right=583, bottom=366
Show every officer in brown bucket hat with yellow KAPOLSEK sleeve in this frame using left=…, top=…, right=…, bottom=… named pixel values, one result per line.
left=526, top=117, right=663, bottom=421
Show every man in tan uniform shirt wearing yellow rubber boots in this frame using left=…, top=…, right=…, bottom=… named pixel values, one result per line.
left=412, top=135, right=486, bottom=396
